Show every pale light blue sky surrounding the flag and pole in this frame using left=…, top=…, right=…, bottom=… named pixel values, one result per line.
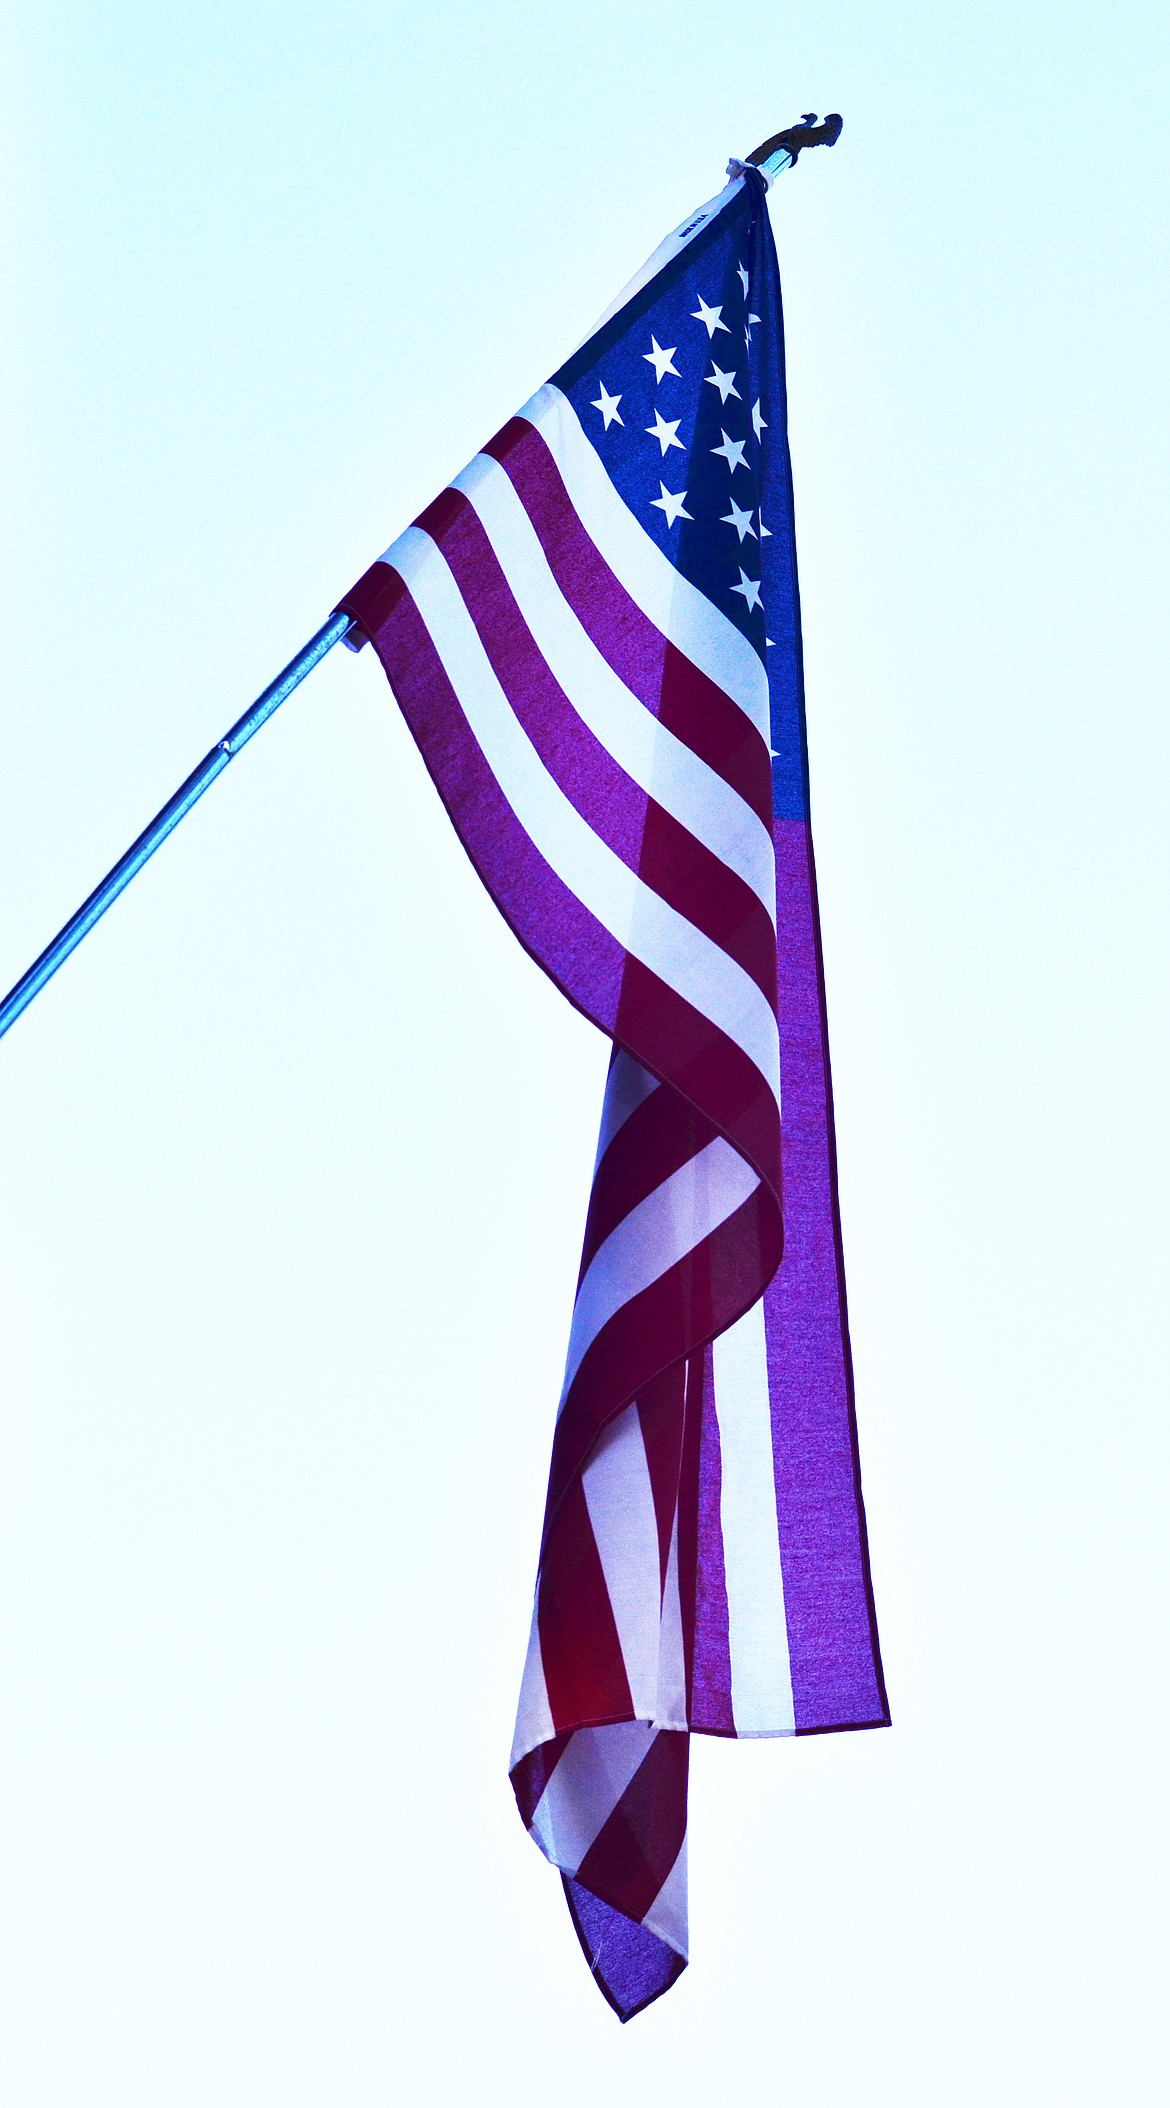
left=0, top=0, right=1170, bottom=2108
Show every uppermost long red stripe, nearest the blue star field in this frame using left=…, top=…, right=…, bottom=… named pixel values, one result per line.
left=483, top=417, right=772, bottom=828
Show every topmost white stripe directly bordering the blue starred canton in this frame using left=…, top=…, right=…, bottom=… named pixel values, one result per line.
left=516, top=382, right=772, bottom=746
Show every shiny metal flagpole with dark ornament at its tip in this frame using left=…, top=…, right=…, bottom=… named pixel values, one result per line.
left=0, top=110, right=841, bottom=1039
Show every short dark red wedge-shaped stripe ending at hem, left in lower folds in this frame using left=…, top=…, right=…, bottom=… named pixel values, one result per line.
left=535, top=1478, right=635, bottom=1733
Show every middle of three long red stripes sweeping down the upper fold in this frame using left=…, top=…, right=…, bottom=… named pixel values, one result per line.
left=417, top=489, right=776, bottom=1008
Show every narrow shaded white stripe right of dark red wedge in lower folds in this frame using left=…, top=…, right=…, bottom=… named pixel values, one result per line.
left=582, top=1404, right=662, bottom=1720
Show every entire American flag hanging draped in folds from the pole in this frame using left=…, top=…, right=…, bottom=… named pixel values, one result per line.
left=342, top=169, right=890, bottom=2019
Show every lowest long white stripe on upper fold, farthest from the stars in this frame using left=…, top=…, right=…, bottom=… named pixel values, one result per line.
left=388, top=527, right=780, bottom=1100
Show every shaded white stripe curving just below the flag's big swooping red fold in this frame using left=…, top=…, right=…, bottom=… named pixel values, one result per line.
left=561, top=1136, right=759, bottom=1400
